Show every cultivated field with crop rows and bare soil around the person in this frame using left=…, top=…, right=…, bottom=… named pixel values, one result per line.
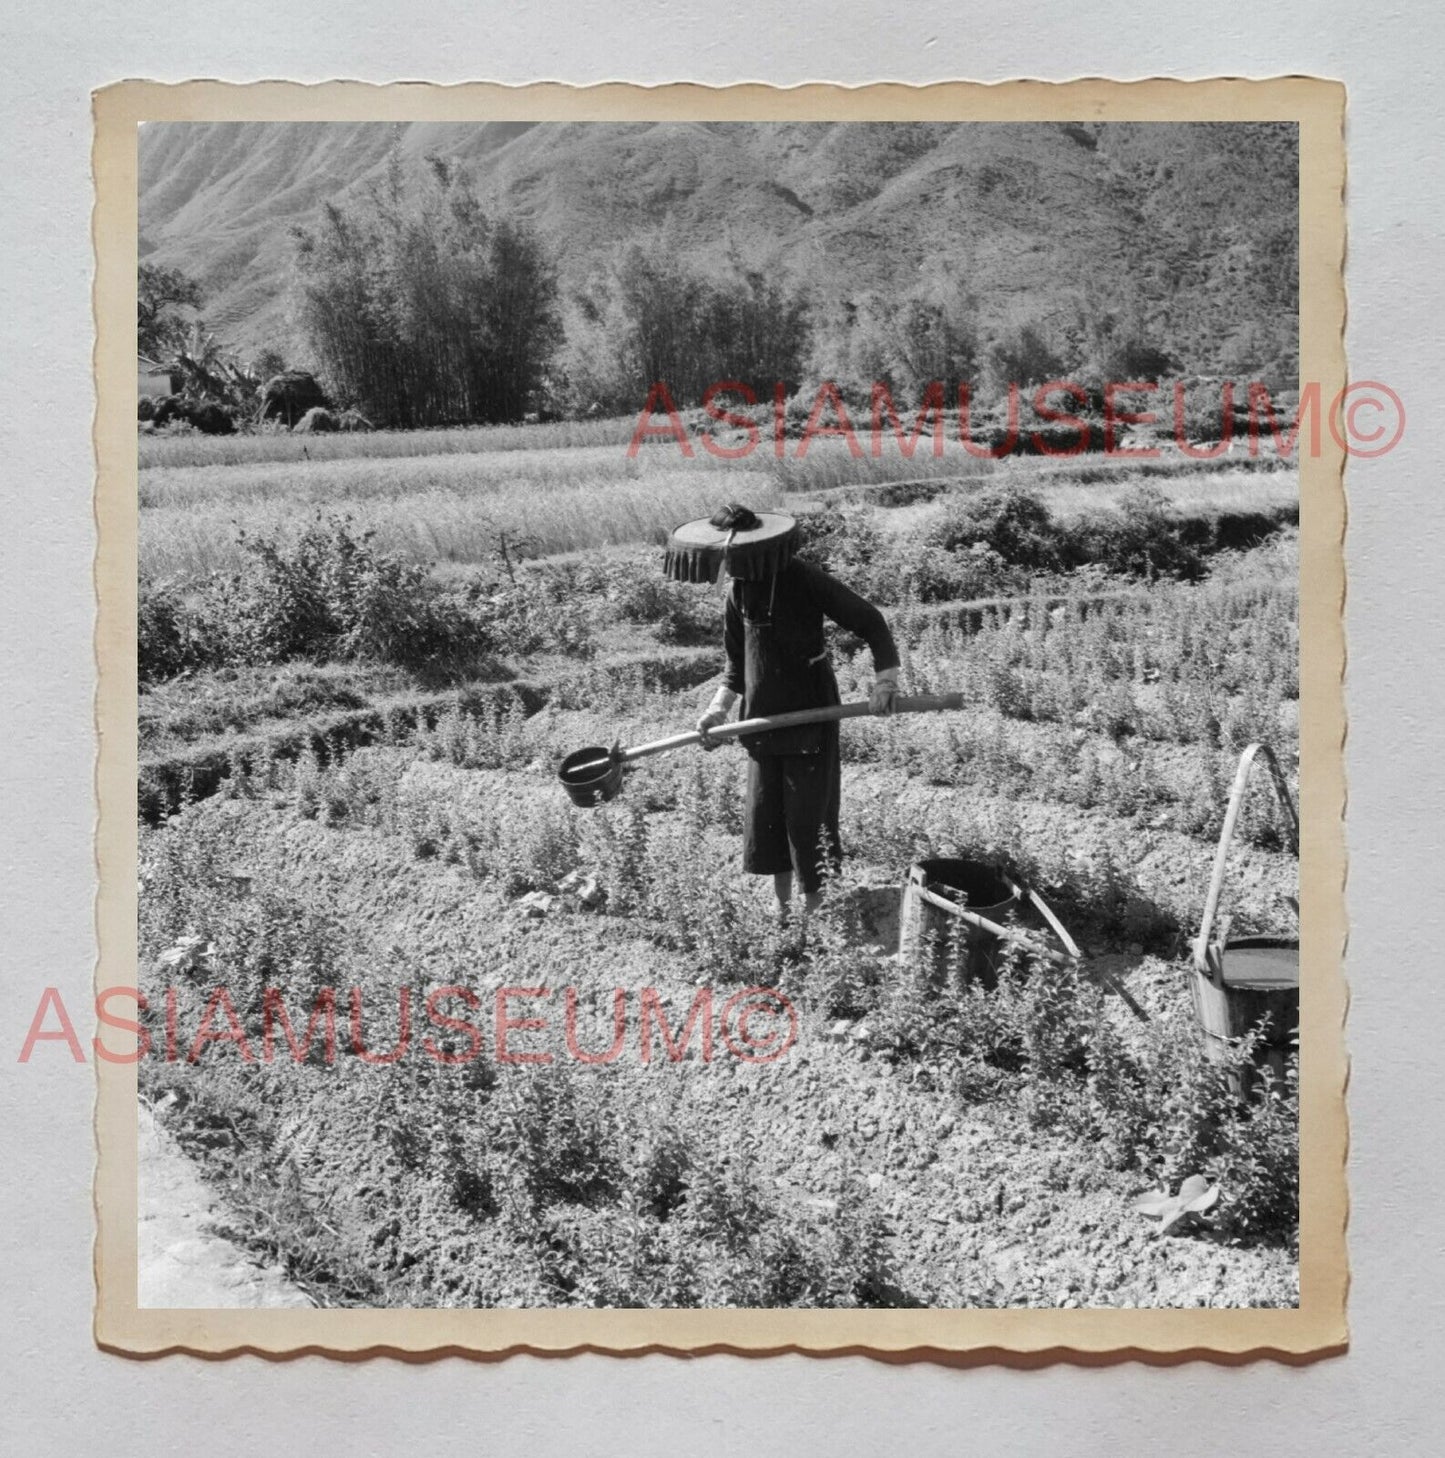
left=139, top=421, right=1299, bottom=1306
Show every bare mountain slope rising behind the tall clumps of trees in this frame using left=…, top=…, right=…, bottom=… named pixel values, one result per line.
left=140, top=122, right=1296, bottom=370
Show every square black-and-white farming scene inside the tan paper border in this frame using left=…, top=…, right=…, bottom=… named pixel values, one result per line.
left=115, top=88, right=1334, bottom=1311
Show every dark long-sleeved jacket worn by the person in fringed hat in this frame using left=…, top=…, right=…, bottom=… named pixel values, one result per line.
left=723, top=560, right=898, bottom=755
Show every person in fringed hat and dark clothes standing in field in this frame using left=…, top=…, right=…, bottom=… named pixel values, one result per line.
left=665, top=504, right=898, bottom=923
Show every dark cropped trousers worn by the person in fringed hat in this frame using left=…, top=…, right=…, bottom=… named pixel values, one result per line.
left=742, top=723, right=843, bottom=892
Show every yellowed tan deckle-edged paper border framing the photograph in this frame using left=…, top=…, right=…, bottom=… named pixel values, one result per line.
left=93, top=77, right=1349, bottom=1366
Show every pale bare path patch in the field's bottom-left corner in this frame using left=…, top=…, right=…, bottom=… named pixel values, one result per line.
left=136, top=1107, right=313, bottom=1308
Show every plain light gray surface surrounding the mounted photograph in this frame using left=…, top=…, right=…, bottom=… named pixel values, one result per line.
left=0, top=0, right=1445, bottom=1458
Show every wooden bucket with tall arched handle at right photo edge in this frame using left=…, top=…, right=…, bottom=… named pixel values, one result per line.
left=1190, top=744, right=1299, bottom=1094
